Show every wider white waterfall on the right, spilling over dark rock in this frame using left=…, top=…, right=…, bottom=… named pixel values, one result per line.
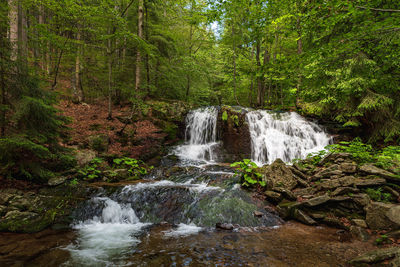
left=247, top=110, right=331, bottom=165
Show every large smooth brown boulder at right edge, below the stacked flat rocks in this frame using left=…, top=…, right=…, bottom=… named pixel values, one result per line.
left=366, top=202, right=400, bottom=230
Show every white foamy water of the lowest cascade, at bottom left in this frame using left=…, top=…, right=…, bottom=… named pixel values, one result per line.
left=66, top=198, right=148, bottom=266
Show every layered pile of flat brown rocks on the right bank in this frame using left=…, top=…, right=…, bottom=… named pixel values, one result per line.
left=258, top=153, right=400, bottom=266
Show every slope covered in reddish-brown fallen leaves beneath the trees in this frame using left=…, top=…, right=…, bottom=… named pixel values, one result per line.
left=58, top=100, right=166, bottom=158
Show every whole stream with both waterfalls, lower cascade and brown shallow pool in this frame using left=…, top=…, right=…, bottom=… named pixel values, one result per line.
left=0, top=107, right=374, bottom=266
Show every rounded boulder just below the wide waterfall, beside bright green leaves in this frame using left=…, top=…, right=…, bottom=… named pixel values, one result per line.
left=260, top=159, right=297, bottom=190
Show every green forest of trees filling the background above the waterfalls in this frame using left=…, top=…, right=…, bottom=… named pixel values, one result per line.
left=0, top=0, right=400, bottom=172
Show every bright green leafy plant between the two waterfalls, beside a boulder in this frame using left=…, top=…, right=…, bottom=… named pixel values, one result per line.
left=231, top=159, right=266, bottom=187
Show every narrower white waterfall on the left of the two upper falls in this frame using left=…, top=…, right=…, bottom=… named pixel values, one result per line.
left=174, top=107, right=218, bottom=162
